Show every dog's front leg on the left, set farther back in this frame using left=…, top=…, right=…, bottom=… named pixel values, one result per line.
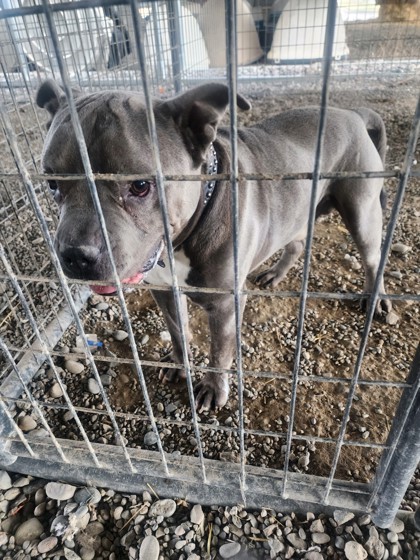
left=152, top=290, right=191, bottom=382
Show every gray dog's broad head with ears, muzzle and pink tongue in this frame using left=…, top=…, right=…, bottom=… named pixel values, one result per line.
left=36, top=80, right=250, bottom=293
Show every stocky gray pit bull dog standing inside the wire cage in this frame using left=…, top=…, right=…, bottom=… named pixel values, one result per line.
left=37, top=81, right=390, bottom=409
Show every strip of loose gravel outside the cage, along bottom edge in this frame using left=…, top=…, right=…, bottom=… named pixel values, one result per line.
left=0, top=471, right=420, bottom=560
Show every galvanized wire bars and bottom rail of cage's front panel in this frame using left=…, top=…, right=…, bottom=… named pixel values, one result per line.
left=0, top=0, right=420, bottom=526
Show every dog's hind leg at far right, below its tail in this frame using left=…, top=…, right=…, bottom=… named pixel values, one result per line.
left=335, top=179, right=392, bottom=314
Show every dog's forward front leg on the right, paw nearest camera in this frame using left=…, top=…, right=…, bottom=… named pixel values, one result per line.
left=194, top=295, right=246, bottom=410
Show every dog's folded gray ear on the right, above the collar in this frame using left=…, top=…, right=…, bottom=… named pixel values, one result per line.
left=164, top=83, right=251, bottom=165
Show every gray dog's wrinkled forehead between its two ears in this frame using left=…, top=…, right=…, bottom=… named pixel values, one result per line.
left=42, top=92, right=151, bottom=173
